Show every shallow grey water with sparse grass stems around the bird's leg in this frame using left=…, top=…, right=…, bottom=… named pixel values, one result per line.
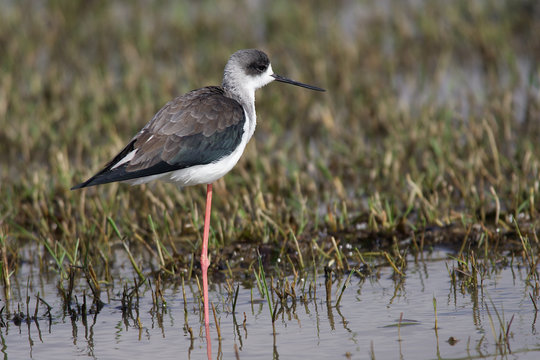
left=0, top=251, right=540, bottom=359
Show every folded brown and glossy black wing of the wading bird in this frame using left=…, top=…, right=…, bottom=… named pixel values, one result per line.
left=72, top=86, right=246, bottom=190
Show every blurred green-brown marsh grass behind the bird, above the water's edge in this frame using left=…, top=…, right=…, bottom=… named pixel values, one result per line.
left=0, top=0, right=540, bottom=278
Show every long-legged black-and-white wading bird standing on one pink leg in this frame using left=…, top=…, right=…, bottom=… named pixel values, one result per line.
left=72, top=49, right=325, bottom=329
